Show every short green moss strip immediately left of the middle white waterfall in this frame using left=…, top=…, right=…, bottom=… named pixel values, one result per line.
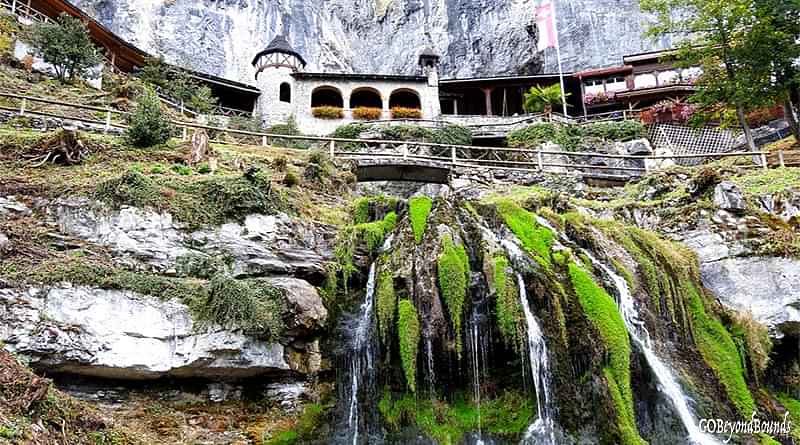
left=493, top=255, right=524, bottom=352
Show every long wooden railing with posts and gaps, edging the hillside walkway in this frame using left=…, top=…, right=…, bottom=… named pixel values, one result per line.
left=0, top=92, right=768, bottom=176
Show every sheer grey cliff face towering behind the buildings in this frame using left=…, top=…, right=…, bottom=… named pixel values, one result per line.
left=77, top=0, right=669, bottom=83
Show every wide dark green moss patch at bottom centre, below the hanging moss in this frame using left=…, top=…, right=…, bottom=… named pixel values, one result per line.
left=378, top=391, right=536, bottom=445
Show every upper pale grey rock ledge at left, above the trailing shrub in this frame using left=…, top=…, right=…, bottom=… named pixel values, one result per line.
left=51, top=199, right=335, bottom=280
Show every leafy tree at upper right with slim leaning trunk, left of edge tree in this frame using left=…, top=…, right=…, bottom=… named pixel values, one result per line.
left=641, top=0, right=770, bottom=150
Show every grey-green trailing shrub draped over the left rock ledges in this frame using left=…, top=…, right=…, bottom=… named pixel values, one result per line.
left=195, top=274, right=284, bottom=341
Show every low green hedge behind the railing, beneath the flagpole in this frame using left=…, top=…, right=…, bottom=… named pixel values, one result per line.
left=508, top=121, right=646, bottom=151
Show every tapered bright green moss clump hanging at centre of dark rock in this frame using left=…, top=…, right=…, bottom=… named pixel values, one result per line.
left=437, top=234, right=470, bottom=357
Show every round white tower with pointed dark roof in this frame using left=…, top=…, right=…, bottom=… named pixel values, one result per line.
left=253, top=35, right=306, bottom=125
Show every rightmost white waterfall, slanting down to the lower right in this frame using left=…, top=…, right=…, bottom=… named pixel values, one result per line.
left=583, top=249, right=719, bottom=445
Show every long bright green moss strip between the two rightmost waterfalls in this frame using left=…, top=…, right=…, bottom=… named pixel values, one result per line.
left=568, top=262, right=643, bottom=444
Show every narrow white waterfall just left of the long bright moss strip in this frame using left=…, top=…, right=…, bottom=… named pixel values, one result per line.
left=517, top=273, right=556, bottom=444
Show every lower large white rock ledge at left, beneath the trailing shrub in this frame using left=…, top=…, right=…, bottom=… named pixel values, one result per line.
left=0, top=280, right=327, bottom=379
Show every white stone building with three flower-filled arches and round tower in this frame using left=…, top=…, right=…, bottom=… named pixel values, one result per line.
left=253, top=36, right=441, bottom=135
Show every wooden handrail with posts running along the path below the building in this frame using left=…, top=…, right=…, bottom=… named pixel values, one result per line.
left=0, top=91, right=767, bottom=171
